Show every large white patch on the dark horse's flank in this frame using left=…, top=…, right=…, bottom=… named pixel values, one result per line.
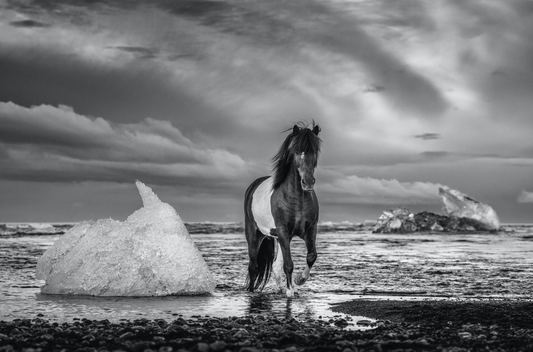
left=252, top=177, right=276, bottom=236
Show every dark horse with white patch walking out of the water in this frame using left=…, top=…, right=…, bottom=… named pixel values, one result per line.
left=244, top=123, right=321, bottom=297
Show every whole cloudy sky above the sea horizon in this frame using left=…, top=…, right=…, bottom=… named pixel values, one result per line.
left=0, top=0, right=533, bottom=223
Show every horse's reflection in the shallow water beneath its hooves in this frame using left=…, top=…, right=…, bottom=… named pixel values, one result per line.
left=247, top=293, right=316, bottom=319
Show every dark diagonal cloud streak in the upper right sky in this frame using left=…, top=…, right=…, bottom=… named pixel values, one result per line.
left=317, top=3, right=449, bottom=119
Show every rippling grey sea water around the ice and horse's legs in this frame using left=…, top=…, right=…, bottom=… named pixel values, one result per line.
left=0, top=224, right=533, bottom=322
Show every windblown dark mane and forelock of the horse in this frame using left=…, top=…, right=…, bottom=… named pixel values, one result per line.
left=272, top=121, right=322, bottom=189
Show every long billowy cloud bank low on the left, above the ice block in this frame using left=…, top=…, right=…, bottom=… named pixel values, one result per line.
left=0, top=103, right=247, bottom=184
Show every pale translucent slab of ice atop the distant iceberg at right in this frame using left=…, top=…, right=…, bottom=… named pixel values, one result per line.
left=439, top=187, right=500, bottom=230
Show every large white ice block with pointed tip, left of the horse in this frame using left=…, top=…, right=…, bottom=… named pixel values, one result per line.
left=36, top=181, right=216, bottom=296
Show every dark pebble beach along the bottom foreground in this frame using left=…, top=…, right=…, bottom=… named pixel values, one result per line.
left=0, top=299, right=533, bottom=352
